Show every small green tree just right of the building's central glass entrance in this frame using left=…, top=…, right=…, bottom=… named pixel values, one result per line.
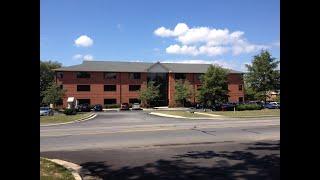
left=174, top=80, right=192, bottom=106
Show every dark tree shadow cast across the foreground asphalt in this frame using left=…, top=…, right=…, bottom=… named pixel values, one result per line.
left=81, top=142, right=280, bottom=180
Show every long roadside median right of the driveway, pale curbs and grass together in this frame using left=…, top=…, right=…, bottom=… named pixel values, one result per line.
left=150, top=109, right=280, bottom=119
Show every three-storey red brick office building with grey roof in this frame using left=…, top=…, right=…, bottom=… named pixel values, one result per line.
left=55, top=61, right=244, bottom=107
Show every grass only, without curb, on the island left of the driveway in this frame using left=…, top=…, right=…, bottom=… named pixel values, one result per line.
left=40, top=112, right=91, bottom=124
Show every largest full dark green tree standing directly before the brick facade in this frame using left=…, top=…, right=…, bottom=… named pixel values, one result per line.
left=198, top=65, right=229, bottom=105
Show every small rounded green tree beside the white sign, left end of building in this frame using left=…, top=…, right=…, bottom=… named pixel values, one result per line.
left=41, top=83, right=65, bottom=106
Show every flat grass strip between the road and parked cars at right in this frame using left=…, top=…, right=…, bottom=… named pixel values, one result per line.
left=207, top=109, right=280, bottom=117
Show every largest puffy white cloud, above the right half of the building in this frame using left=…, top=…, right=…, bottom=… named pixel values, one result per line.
left=154, top=23, right=268, bottom=56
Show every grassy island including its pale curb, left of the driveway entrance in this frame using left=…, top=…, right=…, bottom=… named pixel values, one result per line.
left=40, top=112, right=95, bottom=125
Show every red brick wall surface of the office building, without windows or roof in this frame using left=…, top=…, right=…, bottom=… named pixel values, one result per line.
left=57, top=72, right=244, bottom=107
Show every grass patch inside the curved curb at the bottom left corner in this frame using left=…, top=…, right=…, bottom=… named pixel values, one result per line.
left=40, top=158, right=74, bottom=180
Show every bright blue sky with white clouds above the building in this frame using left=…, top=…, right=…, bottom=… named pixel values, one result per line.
left=40, top=0, right=280, bottom=70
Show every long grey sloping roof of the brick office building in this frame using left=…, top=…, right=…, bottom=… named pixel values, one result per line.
left=54, top=61, right=243, bottom=73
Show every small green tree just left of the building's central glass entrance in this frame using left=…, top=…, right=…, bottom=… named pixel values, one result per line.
left=139, top=81, right=160, bottom=107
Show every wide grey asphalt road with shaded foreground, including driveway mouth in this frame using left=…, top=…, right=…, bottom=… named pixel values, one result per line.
left=40, top=111, right=280, bottom=179
